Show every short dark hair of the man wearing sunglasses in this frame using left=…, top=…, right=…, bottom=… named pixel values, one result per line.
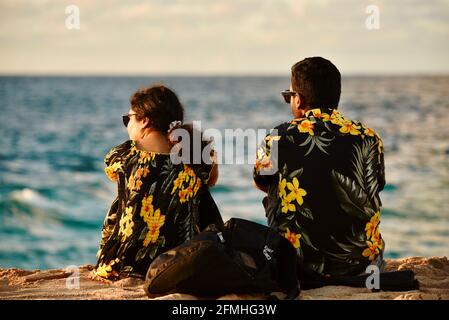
left=291, top=57, right=341, bottom=109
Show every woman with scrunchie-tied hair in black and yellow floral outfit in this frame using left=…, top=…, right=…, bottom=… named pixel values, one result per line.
left=94, top=86, right=223, bottom=280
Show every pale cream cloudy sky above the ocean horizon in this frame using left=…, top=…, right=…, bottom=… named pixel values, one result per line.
left=0, top=0, right=449, bottom=75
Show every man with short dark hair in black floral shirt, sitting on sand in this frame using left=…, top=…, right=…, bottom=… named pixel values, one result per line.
left=254, top=57, right=385, bottom=282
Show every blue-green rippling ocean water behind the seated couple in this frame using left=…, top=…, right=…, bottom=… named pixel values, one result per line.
left=0, top=76, right=449, bottom=269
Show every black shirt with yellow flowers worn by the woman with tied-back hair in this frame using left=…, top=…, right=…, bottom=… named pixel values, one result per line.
left=95, top=140, right=221, bottom=279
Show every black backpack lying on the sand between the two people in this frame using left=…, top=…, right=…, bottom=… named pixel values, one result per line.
left=144, top=218, right=300, bottom=299
